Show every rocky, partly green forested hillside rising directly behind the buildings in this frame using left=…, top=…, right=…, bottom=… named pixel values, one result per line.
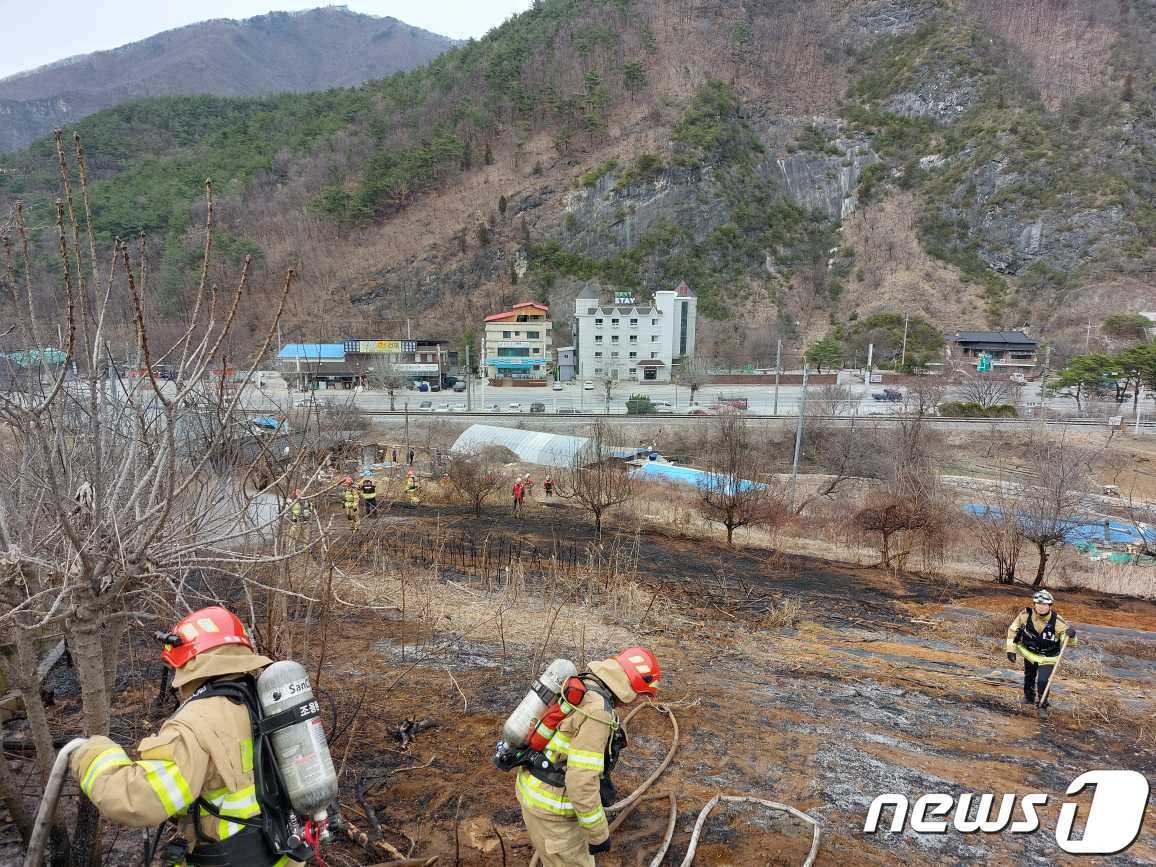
left=0, top=0, right=1156, bottom=363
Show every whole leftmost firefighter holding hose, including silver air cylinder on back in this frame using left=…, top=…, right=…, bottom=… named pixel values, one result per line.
left=69, top=607, right=336, bottom=867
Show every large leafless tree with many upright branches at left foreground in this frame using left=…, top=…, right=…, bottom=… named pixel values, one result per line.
left=0, top=132, right=294, bottom=864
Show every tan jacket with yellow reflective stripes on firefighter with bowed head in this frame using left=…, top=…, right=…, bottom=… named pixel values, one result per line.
left=516, top=690, right=617, bottom=843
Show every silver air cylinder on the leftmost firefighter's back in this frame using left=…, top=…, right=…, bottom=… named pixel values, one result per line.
left=257, top=660, right=338, bottom=821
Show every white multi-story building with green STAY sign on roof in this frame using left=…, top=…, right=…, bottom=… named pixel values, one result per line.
left=575, top=283, right=698, bottom=383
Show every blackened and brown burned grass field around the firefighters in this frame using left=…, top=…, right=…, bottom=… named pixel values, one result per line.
left=9, top=504, right=1156, bottom=867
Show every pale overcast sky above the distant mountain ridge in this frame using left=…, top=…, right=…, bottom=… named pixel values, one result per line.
left=0, top=0, right=531, bottom=77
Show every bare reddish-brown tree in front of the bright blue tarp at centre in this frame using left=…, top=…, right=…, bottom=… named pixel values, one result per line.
left=698, top=413, right=787, bottom=544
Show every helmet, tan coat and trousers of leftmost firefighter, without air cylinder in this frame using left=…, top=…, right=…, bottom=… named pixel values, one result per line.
left=71, top=607, right=299, bottom=867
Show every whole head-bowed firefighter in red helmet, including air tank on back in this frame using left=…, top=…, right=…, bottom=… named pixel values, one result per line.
left=494, top=647, right=662, bottom=867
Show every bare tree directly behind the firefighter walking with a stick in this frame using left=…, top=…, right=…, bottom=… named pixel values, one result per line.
left=1017, top=432, right=1091, bottom=587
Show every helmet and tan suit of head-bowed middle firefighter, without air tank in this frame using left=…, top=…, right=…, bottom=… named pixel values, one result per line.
left=516, top=647, right=662, bottom=867
